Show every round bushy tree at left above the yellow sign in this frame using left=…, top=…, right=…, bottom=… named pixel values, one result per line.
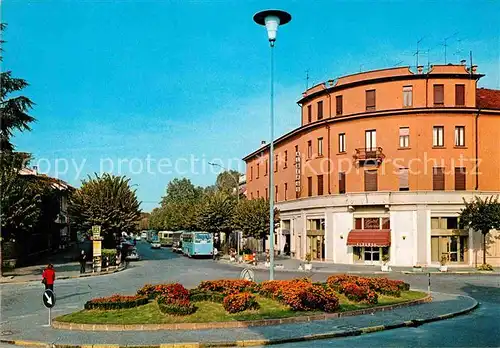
left=69, top=174, right=140, bottom=248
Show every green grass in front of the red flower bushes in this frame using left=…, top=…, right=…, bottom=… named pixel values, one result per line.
left=56, top=291, right=426, bottom=325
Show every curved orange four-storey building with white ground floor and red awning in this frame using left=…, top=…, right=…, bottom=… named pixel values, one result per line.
left=244, top=65, right=500, bottom=266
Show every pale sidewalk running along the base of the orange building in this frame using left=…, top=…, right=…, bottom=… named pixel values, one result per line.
left=219, top=256, right=500, bottom=276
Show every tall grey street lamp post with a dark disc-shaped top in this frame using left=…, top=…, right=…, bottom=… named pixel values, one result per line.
left=253, top=10, right=292, bottom=280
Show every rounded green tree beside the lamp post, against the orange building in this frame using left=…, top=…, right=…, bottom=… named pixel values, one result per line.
left=234, top=198, right=280, bottom=240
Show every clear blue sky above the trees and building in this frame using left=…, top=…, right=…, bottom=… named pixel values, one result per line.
left=1, top=0, right=500, bottom=211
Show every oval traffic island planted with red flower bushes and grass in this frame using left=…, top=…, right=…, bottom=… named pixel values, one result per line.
left=53, top=275, right=431, bottom=331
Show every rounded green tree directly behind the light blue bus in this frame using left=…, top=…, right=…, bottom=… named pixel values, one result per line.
left=198, top=192, right=236, bottom=246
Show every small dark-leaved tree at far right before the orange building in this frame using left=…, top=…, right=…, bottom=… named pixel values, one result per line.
left=460, top=196, right=500, bottom=264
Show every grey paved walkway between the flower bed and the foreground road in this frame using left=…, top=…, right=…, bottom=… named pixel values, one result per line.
left=0, top=293, right=477, bottom=347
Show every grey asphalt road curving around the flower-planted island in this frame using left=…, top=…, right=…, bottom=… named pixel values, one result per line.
left=0, top=242, right=500, bottom=347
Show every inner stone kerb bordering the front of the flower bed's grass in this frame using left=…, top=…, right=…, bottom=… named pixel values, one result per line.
left=52, top=295, right=432, bottom=332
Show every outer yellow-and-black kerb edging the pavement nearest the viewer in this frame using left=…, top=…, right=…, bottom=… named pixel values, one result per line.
left=0, top=295, right=479, bottom=348
